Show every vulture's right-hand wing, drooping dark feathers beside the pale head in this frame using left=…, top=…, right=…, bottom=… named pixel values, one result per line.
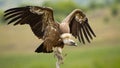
left=64, top=9, right=96, bottom=44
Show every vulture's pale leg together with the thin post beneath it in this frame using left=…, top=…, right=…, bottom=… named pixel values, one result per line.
left=54, top=47, right=63, bottom=68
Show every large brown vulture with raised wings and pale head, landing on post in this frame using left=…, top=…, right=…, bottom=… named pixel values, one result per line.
left=4, top=6, right=96, bottom=67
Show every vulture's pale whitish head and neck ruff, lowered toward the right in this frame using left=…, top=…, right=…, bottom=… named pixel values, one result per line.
left=60, top=33, right=77, bottom=46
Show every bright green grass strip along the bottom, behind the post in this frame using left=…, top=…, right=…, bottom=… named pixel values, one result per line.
left=0, top=45, right=120, bottom=68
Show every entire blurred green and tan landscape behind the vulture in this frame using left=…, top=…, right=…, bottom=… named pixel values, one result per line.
left=0, top=0, right=120, bottom=68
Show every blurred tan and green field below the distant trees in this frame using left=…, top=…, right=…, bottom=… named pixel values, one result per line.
left=0, top=8, right=120, bottom=68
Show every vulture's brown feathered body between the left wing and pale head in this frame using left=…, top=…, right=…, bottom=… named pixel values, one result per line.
left=36, top=24, right=64, bottom=53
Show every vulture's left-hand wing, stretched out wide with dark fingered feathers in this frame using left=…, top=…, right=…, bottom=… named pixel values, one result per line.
left=4, top=6, right=54, bottom=38
